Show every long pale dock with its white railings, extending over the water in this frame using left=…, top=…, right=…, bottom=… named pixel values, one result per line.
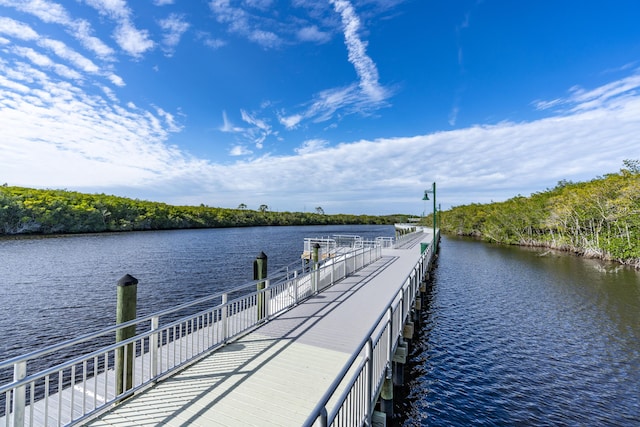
left=0, top=228, right=437, bottom=427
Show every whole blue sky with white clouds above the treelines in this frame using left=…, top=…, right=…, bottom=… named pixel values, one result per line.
left=0, top=0, right=640, bottom=214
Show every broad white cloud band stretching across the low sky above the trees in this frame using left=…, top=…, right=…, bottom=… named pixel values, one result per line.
left=6, top=69, right=640, bottom=213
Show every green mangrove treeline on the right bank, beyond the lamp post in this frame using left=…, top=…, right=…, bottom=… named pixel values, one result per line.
left=440, top=160, right=640, bottom=268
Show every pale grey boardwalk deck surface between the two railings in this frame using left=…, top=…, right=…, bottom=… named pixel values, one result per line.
left=86, top=232, right=432, bottom=426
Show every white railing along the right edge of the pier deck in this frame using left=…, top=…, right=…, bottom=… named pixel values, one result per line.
left=304, top=232, right=439, bottom=426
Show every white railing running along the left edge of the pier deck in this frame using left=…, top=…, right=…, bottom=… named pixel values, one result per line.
left=0, top=245, right=382, bottom=427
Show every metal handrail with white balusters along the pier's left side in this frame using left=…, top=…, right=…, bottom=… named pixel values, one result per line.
left=0, top=239, right=392, bottom=426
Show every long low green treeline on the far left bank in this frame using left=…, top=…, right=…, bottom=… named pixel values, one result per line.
left=0, top=185, right=406, bottom=235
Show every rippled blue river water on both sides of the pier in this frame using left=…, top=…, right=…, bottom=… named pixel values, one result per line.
left=0, top=226, right=640, bottom=426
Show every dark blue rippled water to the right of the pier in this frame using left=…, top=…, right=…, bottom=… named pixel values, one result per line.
left=397, top=238, right=640, bottom=426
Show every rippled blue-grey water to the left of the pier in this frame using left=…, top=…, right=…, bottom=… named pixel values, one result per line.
left=0, top=226, right=394, bottom=360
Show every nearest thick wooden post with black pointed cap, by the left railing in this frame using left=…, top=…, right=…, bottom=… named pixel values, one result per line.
left=116, top=274, right=138, bottom=395
